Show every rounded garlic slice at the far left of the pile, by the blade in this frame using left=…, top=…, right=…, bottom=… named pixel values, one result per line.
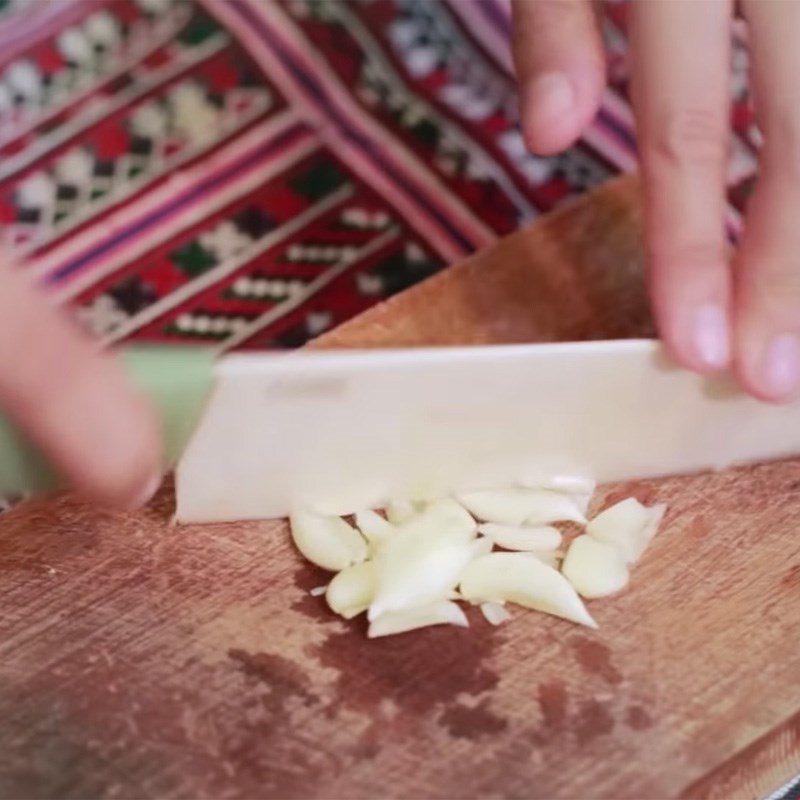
left=289, top=511, right=367, bottom=572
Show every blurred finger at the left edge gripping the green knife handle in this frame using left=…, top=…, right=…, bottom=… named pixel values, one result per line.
left=0, top=267, right=160, bottom=507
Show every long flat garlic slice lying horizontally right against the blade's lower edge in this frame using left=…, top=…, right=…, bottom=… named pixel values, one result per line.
left=458, top=487, right=586, bottom=525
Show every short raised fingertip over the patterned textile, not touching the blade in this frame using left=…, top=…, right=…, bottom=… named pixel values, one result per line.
left=512, top=0, right=606, bottom=155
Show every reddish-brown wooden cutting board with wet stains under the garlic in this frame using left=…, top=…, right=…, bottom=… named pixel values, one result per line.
left=0, top=179, right=800, bottom=799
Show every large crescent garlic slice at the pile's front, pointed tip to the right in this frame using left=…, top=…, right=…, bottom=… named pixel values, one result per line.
left=460, top=553, right=597, bottom=628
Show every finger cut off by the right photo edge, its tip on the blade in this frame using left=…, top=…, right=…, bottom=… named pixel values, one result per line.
left=735, top=2, right=800, bottom=401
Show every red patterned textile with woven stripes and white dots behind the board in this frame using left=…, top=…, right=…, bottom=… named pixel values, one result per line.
left=0, top=0, right=759, bottom=350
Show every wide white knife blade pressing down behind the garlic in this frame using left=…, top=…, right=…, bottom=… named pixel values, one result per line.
left=177, top=340, right=800, bottom=522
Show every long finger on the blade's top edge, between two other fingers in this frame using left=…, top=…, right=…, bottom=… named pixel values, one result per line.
left=631, top=0, right=731, bottom=372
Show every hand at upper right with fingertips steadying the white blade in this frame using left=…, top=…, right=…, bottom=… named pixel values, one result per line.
left=514, top=0, right=800, bottom=401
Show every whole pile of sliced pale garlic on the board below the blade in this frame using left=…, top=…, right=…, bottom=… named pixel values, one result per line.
left=290, top=476, right=665, bottom=638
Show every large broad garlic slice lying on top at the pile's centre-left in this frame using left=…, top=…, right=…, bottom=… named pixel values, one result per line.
left=367, top=528, right=486, bottom=621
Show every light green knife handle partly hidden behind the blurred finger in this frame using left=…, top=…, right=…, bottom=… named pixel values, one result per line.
left=0, top=346, right=214, bottom=497
